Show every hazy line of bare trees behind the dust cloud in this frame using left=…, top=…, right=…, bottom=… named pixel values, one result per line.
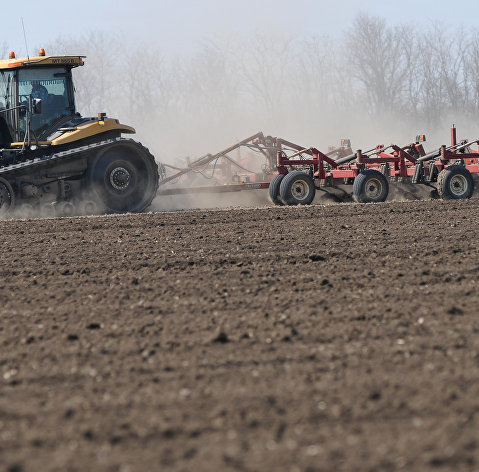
left=0, top=14, right=479, bottom=160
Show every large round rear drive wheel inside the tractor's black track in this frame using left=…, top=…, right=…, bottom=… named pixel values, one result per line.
left=87, top=140, right=158, bottom=213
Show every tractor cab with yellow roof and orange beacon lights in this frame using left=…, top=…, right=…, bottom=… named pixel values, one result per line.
left=0, top=50, right=83, bottom=148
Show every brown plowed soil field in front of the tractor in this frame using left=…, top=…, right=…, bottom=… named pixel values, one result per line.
left=0, top=200, right=479, bottom=472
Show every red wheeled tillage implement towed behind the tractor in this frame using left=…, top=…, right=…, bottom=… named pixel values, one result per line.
left=158, top=126, right=479, bottom=205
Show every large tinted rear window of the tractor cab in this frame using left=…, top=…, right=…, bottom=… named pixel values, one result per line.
left=18, top=67, right=74, bottom=139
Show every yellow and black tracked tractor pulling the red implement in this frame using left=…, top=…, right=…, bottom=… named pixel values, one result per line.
left=0, top=49, right=163, bottom=216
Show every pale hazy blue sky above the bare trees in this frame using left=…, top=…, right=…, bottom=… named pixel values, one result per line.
left=0, top=0, right=479, bottom=56
